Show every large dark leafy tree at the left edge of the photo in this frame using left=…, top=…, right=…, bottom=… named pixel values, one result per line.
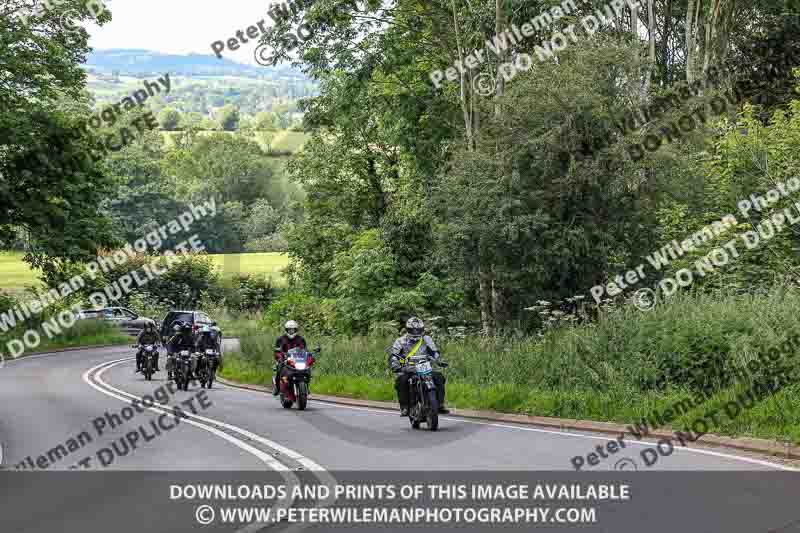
left=0, top=0, right=116, bottom=274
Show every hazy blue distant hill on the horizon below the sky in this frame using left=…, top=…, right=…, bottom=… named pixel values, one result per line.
left=85, top=48, right=308, bottom=81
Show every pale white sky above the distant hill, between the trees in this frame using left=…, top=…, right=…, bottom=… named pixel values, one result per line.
left=86, top=0, right=280, bottom=64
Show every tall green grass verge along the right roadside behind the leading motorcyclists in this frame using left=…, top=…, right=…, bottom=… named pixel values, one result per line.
left=224, top=288, right=800, bottom=440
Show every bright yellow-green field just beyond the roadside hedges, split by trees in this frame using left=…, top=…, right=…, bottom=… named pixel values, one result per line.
left=0, top=252, right=289, bottom=292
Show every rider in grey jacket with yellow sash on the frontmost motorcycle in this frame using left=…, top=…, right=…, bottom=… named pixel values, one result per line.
left=389, top=316, right=450, bottom=416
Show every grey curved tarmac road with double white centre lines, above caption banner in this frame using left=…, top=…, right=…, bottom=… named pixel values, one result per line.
left=0, top=340, right=784, bottom=472
